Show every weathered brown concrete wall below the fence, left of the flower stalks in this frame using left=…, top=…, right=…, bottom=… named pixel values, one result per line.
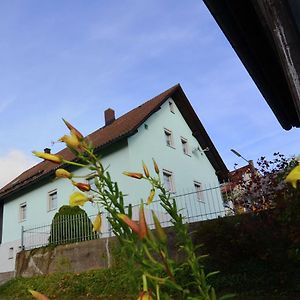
left=16, top=238, right=114, bottom=277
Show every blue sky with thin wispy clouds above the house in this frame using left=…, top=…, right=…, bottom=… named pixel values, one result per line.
left=0, top=0, right=300, bottom=187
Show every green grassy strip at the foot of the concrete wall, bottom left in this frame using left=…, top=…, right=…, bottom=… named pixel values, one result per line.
left=0, top=268, right=138, bottom=300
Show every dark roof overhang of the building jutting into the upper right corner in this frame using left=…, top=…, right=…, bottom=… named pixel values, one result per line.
left=203, top=0, right=300, bottom=130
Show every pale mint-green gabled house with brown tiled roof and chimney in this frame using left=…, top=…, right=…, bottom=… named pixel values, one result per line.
left=0, top=85, right=228, bottom=273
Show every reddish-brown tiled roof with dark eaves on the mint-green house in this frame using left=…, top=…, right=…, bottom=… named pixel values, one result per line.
left=0, top=84, right=228, bottom=201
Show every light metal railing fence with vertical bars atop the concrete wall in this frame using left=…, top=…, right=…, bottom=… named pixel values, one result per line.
left=21, top=186, right=229, bottom=250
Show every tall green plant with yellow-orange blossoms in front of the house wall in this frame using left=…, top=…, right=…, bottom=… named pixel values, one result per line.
left=33, top=120, right=229, bottom=300
